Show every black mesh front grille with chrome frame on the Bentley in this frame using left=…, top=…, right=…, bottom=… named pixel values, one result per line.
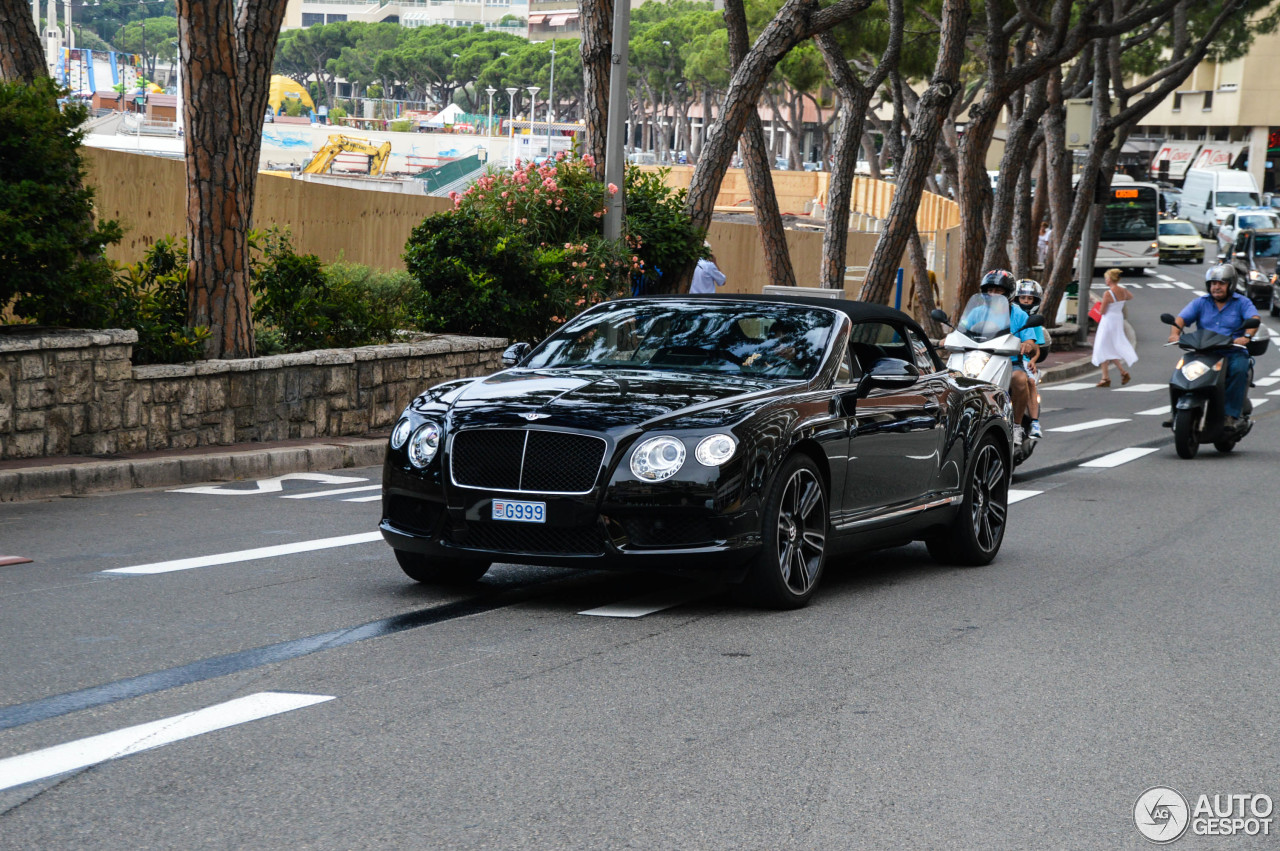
left=449, top=429, right=605, bottom=494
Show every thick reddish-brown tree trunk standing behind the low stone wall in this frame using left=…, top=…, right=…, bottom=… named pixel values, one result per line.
left=178, top=0, right=287, bottom=358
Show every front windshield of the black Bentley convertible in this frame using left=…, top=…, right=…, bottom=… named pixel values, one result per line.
left=525, top=299, right=836, bottom=379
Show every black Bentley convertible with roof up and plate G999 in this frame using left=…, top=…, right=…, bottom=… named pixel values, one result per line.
left=380, top=296, right=1011, bottom=608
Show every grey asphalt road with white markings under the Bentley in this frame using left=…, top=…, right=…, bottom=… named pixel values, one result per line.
left=0, top=255, right=1280, bottom=850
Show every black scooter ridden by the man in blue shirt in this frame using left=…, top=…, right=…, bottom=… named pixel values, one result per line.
left=1160, top=314, right=1270, bottom=458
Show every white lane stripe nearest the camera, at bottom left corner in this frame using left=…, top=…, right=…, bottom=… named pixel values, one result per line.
left=0, top=691, right=333, bottom=790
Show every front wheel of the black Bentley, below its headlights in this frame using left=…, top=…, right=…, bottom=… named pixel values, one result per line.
left=741, top=454, right=829, bottom=609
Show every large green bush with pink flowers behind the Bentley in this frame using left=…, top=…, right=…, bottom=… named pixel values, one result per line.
left=404, top=154, right=701, bottom=340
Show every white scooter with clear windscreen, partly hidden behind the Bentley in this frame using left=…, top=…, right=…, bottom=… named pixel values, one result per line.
left=929, top=293, right=1044, bottom=467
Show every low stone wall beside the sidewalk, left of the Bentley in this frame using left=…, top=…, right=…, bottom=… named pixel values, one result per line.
left=0, top=326, right=506, bottom=461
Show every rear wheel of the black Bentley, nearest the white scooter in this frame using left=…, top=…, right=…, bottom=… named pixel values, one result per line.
left=925, top=438, right=1012, bottom=567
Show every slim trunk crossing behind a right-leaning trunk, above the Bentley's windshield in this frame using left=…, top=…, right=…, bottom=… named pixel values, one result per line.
left=724, top=0, right=796, bottom=287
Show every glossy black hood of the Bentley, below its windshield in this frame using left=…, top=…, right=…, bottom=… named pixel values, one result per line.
left=435, top=369, right=794, bottom=431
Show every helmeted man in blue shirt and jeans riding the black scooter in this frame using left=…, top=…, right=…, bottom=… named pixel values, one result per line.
left=1169, top=264, right=1258, bottom=429
